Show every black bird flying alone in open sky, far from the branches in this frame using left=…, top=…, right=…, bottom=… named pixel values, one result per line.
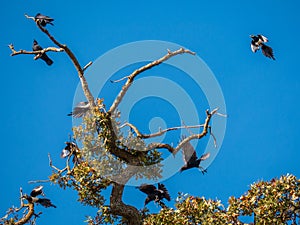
left=250, top=34, right=275, bottom=60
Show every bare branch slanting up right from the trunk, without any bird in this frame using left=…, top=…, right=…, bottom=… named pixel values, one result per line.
left=108, top=48, right=195, bottom=113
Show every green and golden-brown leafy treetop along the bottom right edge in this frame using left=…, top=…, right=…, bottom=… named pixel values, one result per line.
left=143, top=175, right=300, bottom=225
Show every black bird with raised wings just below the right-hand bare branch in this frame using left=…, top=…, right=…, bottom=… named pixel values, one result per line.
left=180, top=137, right=210, bottom=174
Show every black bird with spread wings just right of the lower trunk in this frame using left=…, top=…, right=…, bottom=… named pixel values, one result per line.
left=137, top=183, right=171, bottom=207
